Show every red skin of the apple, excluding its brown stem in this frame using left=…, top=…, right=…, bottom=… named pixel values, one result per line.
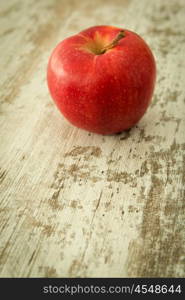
left=47, top=26, right=156, bottom=135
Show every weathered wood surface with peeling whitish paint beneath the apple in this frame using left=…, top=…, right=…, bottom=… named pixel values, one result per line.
left=0, top=0, right=185, bottom=277
